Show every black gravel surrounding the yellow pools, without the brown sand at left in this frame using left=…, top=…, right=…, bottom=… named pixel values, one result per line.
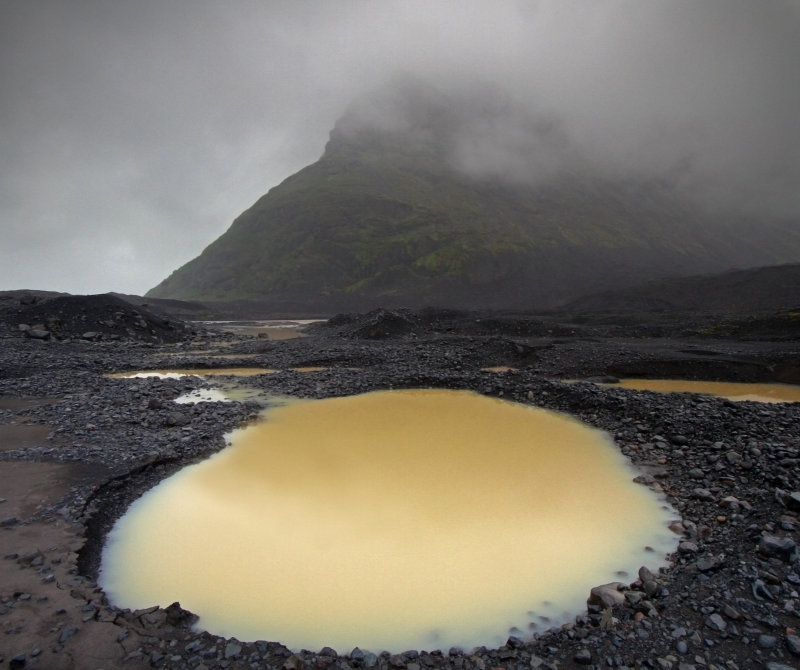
left=0, top=313, right=800, bottom=670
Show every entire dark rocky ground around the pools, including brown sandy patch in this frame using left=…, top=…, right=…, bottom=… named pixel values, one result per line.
left=0, top=307, right=800, bottom=670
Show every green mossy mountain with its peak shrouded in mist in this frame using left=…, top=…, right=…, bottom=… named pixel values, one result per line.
left=146, top=86, right=800, bottom=313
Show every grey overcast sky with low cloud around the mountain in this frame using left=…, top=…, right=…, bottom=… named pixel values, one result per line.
left=0, top=0, right=800, bottom=294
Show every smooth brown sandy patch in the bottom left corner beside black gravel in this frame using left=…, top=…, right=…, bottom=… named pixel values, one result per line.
left=0, top=454, right=131, bottom=670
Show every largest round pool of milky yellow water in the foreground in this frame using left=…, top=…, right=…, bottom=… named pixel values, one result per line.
left=100, top=390, right=676, bottom=652
